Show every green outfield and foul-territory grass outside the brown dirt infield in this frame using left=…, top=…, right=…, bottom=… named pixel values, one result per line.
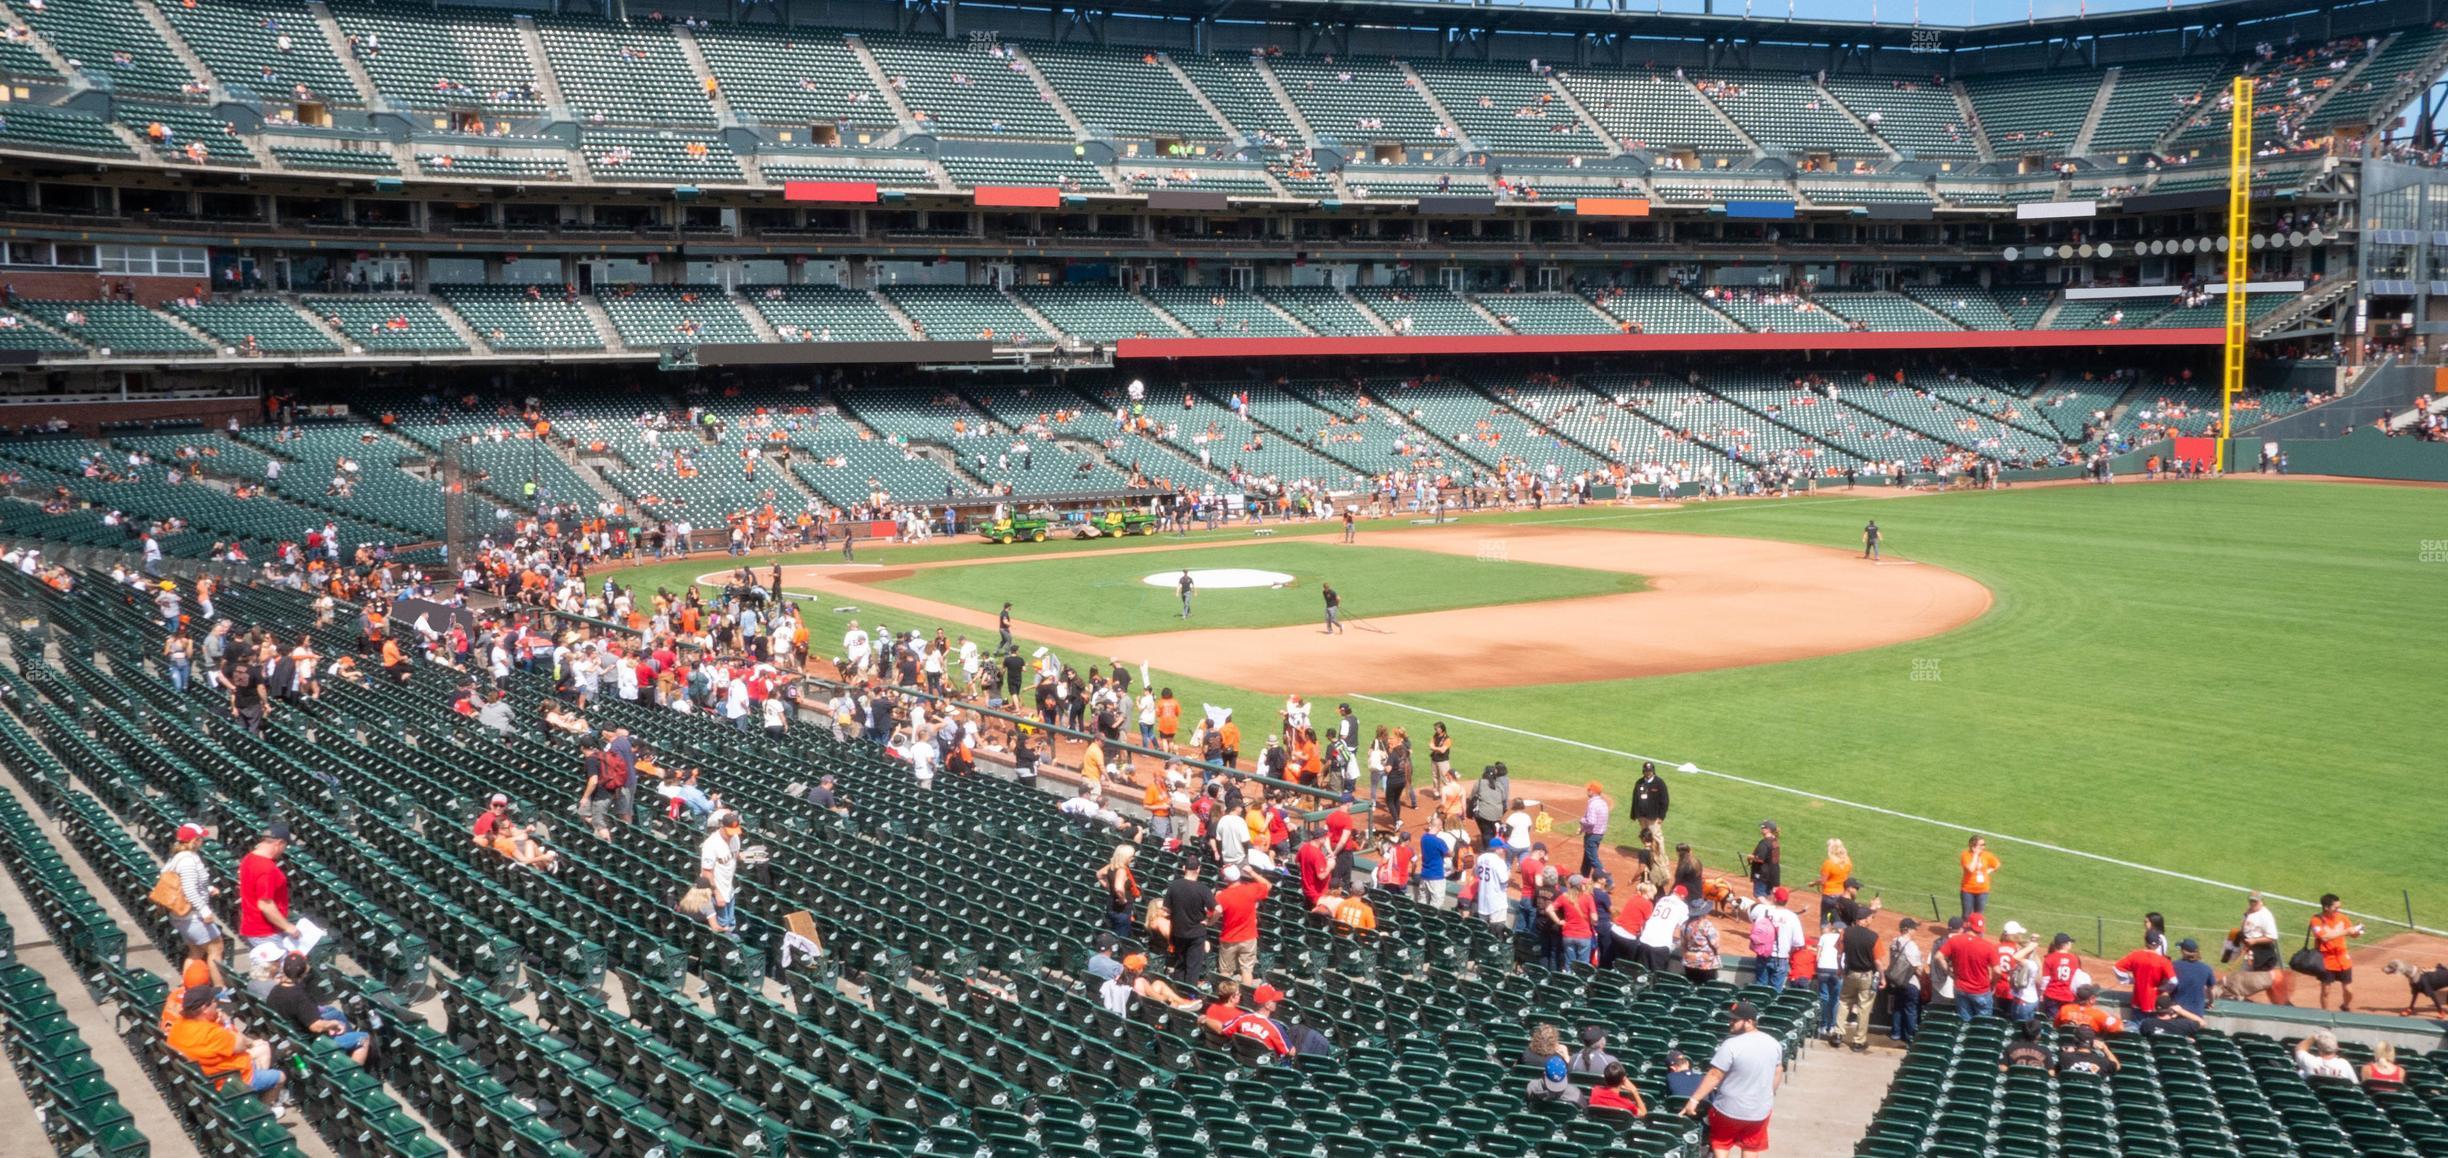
left=607, top=482, right=2448, bottom=965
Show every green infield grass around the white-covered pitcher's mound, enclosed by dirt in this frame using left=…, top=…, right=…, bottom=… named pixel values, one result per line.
left=861, top=541, right=1643, bottom=637
